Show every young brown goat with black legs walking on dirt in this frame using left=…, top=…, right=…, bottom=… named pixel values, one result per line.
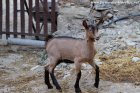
left=45, top=20, right=99, bottom=93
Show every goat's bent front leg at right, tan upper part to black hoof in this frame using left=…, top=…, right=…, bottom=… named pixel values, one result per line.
left=89, top=61, right=100, bottom=88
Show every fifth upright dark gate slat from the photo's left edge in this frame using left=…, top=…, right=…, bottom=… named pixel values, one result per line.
left=28, top=0, right=33, bottom=34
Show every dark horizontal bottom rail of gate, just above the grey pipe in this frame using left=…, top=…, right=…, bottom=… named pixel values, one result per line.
left=2, top=32, right=46, bottom=37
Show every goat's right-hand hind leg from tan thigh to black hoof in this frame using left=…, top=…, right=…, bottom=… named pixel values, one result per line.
left=49, top=60, right=62, bottom=92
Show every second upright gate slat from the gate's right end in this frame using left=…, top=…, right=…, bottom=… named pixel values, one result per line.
left=43, top=0, right=49, bottom=36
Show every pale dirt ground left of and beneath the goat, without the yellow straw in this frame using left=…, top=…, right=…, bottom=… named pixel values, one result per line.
left=0, top=45, right=140, bottom=93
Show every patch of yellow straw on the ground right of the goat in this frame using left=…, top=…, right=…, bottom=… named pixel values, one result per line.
left=99, top=47, right=140, bottom=83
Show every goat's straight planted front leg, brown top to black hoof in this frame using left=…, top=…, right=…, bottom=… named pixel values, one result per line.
left=74, top=61, right=82, bottom=93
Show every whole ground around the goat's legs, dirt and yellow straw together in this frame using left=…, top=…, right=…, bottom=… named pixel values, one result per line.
left=0, top=47, right=140, bottom=93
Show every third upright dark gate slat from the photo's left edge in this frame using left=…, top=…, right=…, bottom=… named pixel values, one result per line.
left=13, top=0, right=17, bottom=38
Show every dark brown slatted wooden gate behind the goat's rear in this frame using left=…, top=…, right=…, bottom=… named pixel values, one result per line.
left=0, top=0, right=57, bottom=39
